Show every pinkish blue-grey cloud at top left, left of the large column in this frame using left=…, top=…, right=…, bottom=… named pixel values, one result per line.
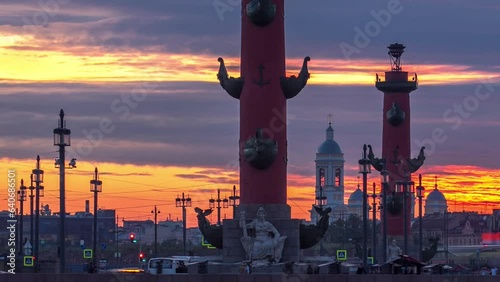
left=0, top=1, right=240, bottom=55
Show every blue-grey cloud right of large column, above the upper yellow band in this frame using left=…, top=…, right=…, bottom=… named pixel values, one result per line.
left=286, top=0, right=500, bottom=66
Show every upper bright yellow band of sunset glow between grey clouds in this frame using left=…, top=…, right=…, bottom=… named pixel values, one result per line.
left=0, top=45, right=500, bottom=85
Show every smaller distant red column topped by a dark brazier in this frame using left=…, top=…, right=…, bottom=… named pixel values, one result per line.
left=369, top=43, right=425, bottom=242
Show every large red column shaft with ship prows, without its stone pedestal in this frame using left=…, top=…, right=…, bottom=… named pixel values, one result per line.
left=217, top=0, right=309, bottom=205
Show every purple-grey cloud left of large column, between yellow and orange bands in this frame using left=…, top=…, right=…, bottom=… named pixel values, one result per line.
left=0, top=80, right=237, bottom=165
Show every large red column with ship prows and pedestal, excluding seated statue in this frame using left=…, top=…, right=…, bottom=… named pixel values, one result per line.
left=217, top=0, right=310, bottom=262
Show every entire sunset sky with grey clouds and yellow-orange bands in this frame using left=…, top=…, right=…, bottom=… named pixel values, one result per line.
left=0, top=0, right=500, bottom=226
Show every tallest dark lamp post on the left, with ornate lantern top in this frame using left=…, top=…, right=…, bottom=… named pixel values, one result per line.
left=54, top=109, right=71, bottom=273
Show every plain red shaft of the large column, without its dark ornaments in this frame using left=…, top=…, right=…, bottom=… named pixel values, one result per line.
left=240, top=0, right=287, bottom=204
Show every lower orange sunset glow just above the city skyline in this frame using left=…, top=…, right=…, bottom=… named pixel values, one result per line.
left=0, top=158, right=500, bottom=227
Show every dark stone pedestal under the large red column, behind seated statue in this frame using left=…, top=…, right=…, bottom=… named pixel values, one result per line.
left=223, top=204, right=300, bottom=263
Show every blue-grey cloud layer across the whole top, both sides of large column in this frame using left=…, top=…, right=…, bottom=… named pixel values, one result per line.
left=0, top=0, right=500, bottom=67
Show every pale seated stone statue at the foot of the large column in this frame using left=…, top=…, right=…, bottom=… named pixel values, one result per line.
left=240, top=207, right=286, bottom=265
